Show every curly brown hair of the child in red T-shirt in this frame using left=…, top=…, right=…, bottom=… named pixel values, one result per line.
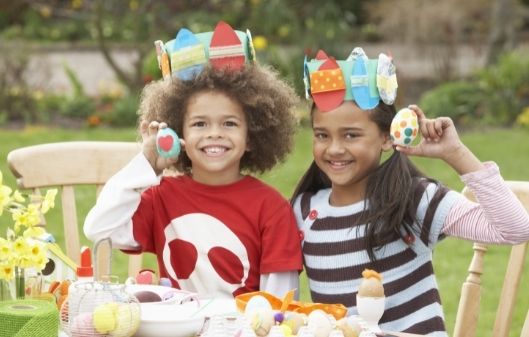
left=138, top=64, right=298, bottom=173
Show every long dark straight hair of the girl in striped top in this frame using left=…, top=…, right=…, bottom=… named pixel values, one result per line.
left=291, top=102, right=434, bottom=261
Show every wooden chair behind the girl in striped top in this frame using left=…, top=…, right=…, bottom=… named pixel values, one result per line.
left=453, top=181, right=529, bottom=337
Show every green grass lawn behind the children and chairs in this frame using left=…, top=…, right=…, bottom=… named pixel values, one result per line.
left=0, top=127, right=529, bottom=336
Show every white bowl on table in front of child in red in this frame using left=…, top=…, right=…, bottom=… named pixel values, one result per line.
left=134, top=298, right=237, bottom=337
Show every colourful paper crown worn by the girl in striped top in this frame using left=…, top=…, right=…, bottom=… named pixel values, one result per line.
left=303, top=47, right=398, bottom=111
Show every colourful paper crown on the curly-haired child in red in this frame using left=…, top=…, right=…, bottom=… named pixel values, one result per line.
left=154, top=21, right=255, bottom=80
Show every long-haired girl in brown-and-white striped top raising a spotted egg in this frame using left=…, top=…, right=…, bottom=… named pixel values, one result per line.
left=292, top=48, right=529, bottom=336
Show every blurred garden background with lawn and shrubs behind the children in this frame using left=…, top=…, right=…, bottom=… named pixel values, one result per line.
left=0, top=0, right=529, bottom=336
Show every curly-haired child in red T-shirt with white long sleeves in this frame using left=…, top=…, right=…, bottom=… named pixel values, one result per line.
left=84, top=22, right=302, bottom=297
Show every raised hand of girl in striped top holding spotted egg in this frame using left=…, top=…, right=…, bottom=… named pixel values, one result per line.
left=396, top=105, right=483, bottom=174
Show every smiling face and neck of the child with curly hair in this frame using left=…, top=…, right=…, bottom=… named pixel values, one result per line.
left=183, top=91, right=248, bottom=185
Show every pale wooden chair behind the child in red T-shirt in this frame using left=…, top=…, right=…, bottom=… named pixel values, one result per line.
left=7, top=141, right=142, bottom=277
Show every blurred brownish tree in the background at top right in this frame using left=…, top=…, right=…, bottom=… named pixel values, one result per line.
left=366, top=0, right=491, bottom=81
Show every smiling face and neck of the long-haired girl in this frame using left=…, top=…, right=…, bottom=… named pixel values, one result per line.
left=312, top=101, right=391, bottom=206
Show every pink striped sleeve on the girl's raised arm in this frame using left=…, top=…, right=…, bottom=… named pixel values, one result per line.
left=442, top=162, right=529, bottom=244
